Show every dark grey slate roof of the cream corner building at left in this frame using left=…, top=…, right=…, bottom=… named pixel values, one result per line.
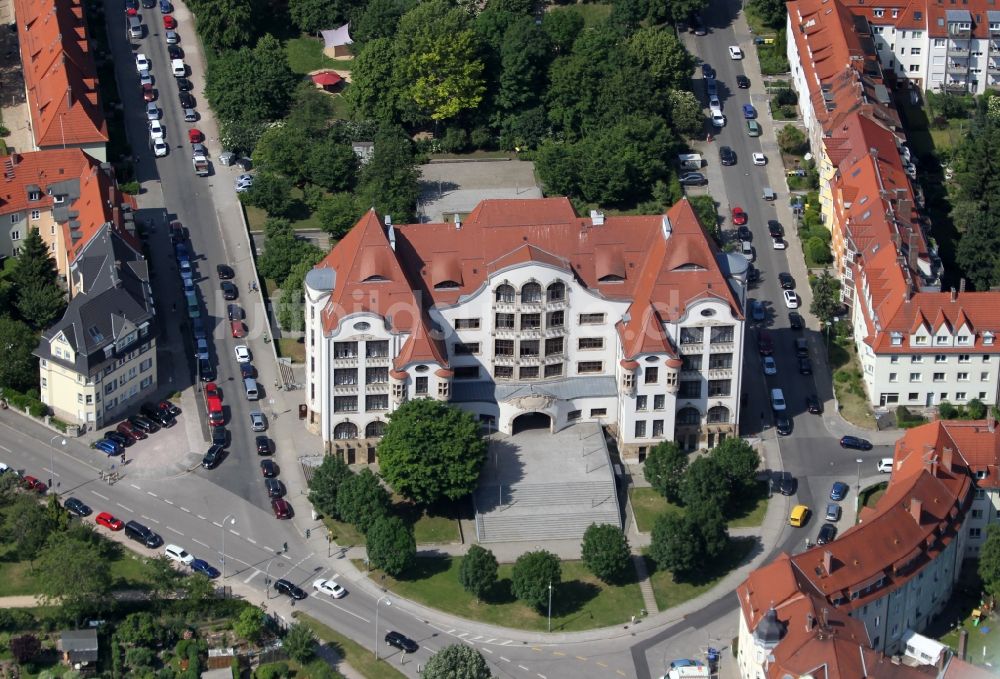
left=35, top=224, right=156, bottom=375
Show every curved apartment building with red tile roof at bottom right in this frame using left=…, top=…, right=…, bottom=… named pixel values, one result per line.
left=737, top=420, right=1000, bottom=679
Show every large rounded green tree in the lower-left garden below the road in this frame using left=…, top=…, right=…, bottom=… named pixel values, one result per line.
left=36, top=533, right=112, bottom=623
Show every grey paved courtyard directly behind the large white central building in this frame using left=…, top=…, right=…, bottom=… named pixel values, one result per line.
left=417, top=159, right=542, bottom=222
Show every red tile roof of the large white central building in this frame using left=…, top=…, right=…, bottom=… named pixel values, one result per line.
left=317, top=198, right=742, bottom=367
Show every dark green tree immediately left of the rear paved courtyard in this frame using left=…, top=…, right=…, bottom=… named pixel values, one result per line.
left=357, top=128, right=420, bottom=223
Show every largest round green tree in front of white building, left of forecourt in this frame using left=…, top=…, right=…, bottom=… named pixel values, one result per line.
left=378, top=399, right=486, bottom=504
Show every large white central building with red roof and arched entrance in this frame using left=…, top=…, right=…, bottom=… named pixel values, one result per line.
left=305, top=198, right=747, bottom=462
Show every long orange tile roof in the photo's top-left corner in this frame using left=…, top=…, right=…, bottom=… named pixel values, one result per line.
left=14, top=0, right=108, bottom=148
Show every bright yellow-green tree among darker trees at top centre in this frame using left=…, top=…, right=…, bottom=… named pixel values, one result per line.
left=394, top=0, right=486, bottom=121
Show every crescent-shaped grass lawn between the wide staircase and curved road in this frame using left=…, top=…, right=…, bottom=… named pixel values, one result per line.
left=370, top=557, right=643, bottom=632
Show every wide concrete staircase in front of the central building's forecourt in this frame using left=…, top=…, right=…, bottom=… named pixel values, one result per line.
left=474, top=475, right=622, bottom=542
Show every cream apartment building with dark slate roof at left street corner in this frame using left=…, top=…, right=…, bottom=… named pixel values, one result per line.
left=35, top=224, right=157, bottom=429
